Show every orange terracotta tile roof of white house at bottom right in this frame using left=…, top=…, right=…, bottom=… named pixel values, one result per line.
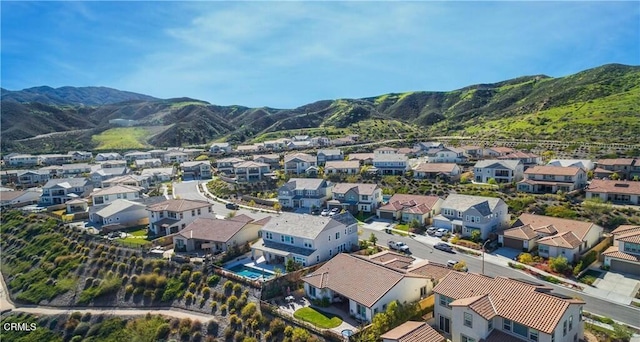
left=434, top=272, right=584, bottom=334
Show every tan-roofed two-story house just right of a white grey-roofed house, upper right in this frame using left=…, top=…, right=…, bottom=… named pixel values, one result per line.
left=518, top=165, right=587, bottom=194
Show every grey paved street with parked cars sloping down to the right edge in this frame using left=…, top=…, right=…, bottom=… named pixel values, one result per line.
left=360, top=228, right=640, bottom=328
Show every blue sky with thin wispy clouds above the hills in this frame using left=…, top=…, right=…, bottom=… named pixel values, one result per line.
left=0, top=1, right=640, bottom=108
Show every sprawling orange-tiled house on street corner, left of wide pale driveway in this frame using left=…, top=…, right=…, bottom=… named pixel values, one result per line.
left=498, top=214, right=603, bottom=261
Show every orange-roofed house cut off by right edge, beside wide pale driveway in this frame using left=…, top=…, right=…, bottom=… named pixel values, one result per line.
left=602, top=225, right=640, bottom=275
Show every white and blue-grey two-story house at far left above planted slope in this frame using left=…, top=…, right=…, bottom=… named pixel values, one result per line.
left=40, top=178, right=93, bottom=206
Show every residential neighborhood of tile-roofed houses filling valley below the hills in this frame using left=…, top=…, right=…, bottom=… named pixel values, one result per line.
left=0, top=140, right=640, bottom=341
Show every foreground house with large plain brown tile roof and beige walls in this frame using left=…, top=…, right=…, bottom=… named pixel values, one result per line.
left=302, top=253, right=448, bottom=322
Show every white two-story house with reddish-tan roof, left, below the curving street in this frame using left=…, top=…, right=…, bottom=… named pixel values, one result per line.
left=147, top=199, right=215, bottom=236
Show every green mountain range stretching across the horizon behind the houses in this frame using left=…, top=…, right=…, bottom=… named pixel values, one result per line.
left=1, top=64, right=640, bottom=152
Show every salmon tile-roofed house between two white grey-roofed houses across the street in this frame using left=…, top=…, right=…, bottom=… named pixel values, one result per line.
left=377, top=194, right=444, bottom=225
